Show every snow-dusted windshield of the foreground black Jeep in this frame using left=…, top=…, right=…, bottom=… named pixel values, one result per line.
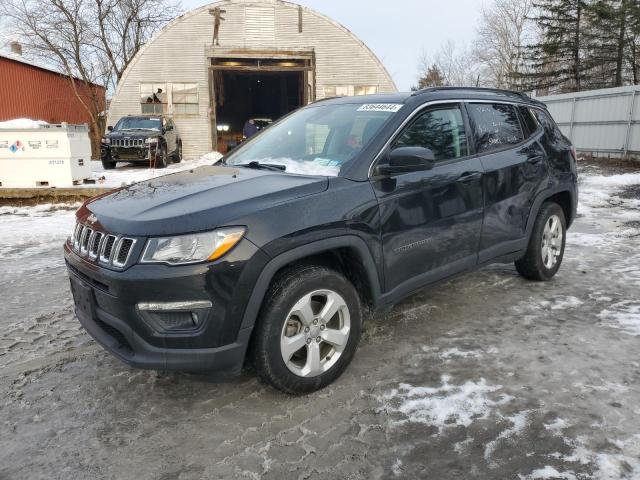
left=226, top=104, right=401, bottom=176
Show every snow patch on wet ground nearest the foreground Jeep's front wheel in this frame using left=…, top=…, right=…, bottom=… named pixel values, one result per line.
left=381, top=375, right=511, bottom=430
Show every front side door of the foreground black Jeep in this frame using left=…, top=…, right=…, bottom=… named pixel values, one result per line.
left=372, top=103, right=483, bottom=295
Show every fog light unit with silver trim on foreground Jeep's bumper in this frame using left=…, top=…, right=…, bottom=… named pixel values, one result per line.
left=137, top=301, right=212, bottom=333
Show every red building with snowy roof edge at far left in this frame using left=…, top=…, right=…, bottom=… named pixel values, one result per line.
left=0, top=48, right=105, bottom=124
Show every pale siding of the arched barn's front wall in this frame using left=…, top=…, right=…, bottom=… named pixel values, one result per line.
left=109, top=0, right=396, bottom=158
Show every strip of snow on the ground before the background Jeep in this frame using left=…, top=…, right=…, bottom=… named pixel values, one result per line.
left=89, top=152, right=222, bottom=188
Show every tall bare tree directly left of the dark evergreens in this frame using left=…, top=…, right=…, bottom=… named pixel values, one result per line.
left=474, top=0, right=535, bottom=90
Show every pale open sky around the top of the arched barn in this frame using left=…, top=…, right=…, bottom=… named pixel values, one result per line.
left=182, top=0, right=482, bottom=91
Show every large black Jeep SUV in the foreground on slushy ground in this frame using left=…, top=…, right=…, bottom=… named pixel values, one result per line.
left=64, top=88, right=577, bottom=393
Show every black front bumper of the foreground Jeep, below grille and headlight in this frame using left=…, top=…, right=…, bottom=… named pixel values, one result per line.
left=64, top=240, right=266, bottom=376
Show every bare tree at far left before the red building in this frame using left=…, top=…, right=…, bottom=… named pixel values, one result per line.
left=0, top=0, right=179, bottom=156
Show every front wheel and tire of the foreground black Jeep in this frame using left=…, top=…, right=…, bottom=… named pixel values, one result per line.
left=249, top=265, right=362, bottom=395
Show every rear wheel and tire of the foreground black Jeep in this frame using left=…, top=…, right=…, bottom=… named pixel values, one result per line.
left=515, top=202, right=567, bottom=282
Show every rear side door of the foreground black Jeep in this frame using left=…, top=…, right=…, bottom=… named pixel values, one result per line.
left=466, top=102, right=548, bottom=263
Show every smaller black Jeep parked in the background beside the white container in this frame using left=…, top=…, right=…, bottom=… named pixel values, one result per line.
left=100, top=115, right=182, bottom=170
